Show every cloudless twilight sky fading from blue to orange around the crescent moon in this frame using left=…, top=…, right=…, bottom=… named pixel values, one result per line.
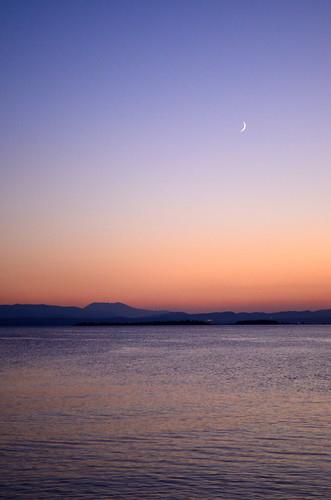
left=0, top=0, right=331, bottom=311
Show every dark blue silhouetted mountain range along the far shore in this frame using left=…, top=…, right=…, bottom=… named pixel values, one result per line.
left=0, top=302, right=331, bottom=326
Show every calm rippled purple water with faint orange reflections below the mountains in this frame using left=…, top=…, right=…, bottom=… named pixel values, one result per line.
left=0, top=326, right=331, bottom=500
